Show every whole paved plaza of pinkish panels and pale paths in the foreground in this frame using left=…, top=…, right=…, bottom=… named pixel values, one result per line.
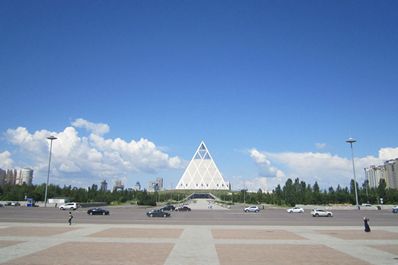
left=0, top=223, right=398, bottom=265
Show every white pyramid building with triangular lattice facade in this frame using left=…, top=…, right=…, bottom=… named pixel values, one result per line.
left=176, top=141, right=229, bottom=190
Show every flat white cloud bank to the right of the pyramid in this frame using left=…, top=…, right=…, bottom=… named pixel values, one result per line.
left=249, top=148, right=398, bottom=190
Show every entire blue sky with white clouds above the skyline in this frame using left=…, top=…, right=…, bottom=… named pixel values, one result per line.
left=0, top=1, right=398, bottom=190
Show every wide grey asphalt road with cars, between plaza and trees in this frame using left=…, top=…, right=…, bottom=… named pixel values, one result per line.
left=0, top=206, right=398, bottom=226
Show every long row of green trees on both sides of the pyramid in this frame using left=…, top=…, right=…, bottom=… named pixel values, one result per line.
left=0, top=178, right=398, bottom=206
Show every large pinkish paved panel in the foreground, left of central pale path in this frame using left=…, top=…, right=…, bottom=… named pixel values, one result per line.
left=3, top=242, right=174, bottom=265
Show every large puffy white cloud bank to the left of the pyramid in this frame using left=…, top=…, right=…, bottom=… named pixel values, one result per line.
left=2, top=119, right=182, bottom=183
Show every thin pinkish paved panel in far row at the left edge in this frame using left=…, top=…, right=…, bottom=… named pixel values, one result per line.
left=0, top=226, right=77, bottom=236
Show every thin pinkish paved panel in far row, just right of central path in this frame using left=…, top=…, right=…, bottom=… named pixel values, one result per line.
left=211, top=229, right=306, bottom=240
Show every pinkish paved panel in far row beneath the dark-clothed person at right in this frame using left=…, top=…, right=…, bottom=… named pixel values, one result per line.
left=316, top=230, right=398, bottom=240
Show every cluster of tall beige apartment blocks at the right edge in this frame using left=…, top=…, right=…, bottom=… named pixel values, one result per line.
left=365, top=158, right=398, bottom=189
